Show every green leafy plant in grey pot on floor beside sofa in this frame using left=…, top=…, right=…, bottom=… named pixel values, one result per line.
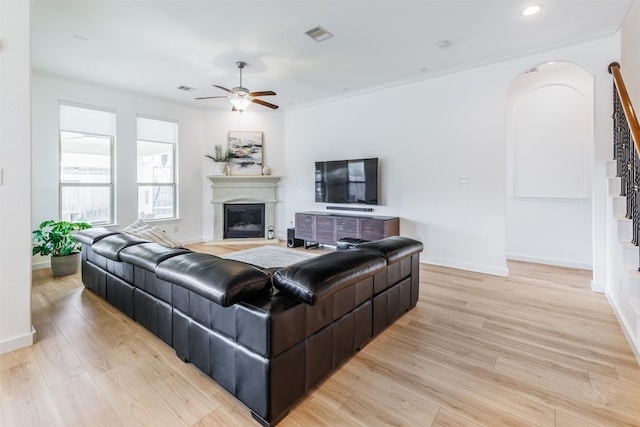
left=31, top=220, right=91, bottom=276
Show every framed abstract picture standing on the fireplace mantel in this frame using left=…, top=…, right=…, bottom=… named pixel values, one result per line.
left=229, top=131, right=263, bottom=175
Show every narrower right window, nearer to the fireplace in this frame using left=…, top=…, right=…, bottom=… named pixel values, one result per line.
left=137, top=116, right=178, bottom=220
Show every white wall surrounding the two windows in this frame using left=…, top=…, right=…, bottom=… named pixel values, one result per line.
left=32, top=72, right=204, bottom=247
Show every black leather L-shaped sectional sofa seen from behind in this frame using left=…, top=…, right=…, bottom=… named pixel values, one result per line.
left=74, top=228, right=422, bottom=425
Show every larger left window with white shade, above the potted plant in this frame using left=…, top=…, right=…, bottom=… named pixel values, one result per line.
left=59, top=103, right=115, bottom=225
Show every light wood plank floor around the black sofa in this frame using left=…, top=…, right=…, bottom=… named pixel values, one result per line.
left=0, top=245, right=640, bottom=427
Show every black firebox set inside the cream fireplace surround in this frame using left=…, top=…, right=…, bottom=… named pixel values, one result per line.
left=224, top=203, right=265, bottom=239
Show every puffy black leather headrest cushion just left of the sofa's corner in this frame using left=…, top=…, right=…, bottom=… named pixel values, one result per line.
left=156, top=252, right=271, bottom=307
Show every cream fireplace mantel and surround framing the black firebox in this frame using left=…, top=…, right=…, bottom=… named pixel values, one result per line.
left=208, top=175, right=280, bottom=240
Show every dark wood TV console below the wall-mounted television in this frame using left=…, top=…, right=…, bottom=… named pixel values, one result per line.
left=295, top=212, right=400, bottom=248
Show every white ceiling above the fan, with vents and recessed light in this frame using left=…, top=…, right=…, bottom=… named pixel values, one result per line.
left=31, top=0, right=631, bottom=111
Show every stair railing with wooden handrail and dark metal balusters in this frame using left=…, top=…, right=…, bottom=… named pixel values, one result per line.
left=608, top=62, right=640, bottom=264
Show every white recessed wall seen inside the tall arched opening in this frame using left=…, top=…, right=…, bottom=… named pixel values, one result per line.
left=507, top=62, right=594, bottom=269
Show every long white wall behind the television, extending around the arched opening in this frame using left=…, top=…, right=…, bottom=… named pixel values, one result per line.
left=283, top=36, right=618, bottom=277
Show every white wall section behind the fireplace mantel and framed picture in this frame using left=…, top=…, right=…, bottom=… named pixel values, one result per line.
left=201, top=110, right=287, bottom=242
